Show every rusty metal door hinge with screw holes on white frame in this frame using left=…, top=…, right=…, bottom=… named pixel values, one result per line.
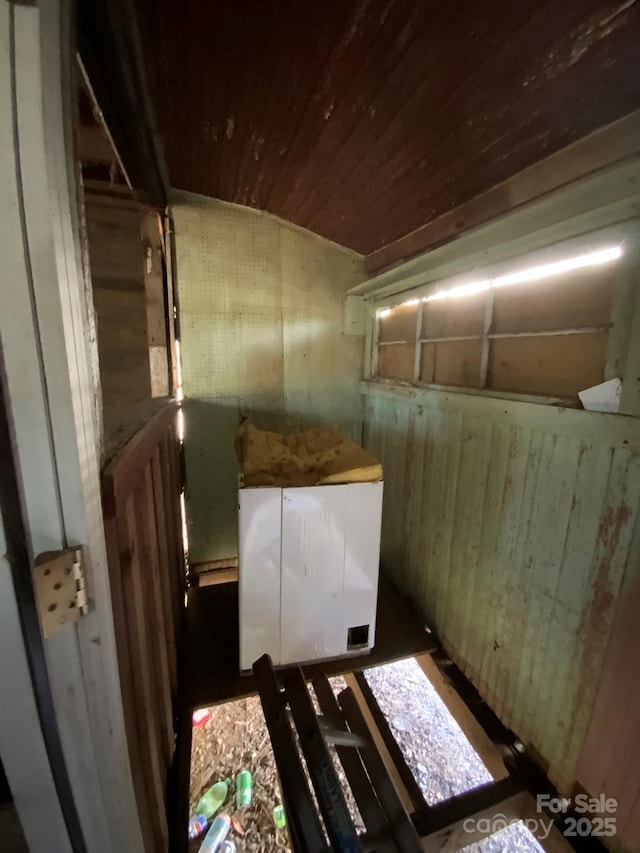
left=33, top=546, right=89, bottom=638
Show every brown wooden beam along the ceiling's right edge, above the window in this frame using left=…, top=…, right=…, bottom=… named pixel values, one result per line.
left=365, top=110, right=640, bottom=275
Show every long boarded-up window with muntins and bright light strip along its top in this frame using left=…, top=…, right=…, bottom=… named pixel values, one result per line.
left=371, top=244, right=624, bottom=404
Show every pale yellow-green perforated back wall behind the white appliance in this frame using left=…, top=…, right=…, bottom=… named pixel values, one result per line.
left=172, top=193, right=363, bottom=563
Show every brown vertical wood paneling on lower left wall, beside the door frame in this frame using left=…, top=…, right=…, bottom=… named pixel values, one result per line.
left=102, top=403, right=185, bottom=853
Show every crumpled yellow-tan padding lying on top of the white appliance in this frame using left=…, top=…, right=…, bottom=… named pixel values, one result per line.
left=235, top=423, right=382, bottom=487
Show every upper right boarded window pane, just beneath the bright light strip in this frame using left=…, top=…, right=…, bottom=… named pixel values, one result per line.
left=492, top=266, right=619, bottom=333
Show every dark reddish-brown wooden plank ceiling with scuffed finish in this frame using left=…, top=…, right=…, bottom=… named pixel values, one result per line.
left=135, top=0, right=640, bottom=254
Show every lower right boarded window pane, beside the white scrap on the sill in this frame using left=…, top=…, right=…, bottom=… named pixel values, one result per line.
left=490, top=332, right=607, bottom=397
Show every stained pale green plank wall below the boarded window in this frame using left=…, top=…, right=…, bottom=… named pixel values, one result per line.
left=365, top=385, right=640, bottom=793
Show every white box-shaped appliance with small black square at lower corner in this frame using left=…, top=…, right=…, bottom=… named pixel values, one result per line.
left=239, top=482, right=383, bottom=670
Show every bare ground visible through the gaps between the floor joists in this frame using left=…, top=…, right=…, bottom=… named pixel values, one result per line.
left=189, top=658, right=542, bottom=853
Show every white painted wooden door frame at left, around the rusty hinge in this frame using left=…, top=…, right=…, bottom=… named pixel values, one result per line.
left=0, top=0, right=143, bottom=853
